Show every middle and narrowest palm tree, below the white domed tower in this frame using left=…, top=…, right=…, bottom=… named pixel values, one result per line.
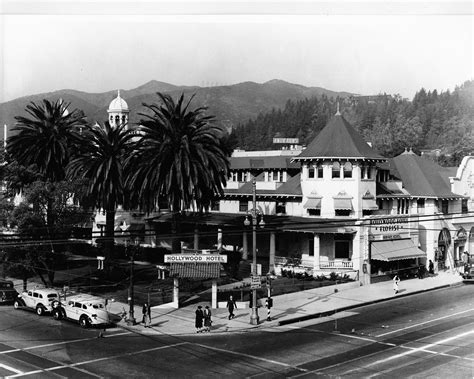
left=67, top=122, right=134, bottom=259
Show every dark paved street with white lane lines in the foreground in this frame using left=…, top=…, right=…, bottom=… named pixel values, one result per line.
left=0, top=285, right=474, bottom=378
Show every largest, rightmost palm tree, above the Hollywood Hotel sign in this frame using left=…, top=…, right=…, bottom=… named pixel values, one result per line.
left=127, top=93, right=230, bottom=253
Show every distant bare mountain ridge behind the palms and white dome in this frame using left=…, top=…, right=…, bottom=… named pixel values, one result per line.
left=0, top=79, right=352, bottom=139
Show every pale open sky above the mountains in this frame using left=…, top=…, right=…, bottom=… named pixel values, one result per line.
left=0, top=0, right=474, bottom=102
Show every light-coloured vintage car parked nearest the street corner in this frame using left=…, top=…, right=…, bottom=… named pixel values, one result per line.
left=52, top=294, right=109, bottom=328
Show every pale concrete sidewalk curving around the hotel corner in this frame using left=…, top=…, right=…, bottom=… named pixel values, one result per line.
left=109, top=272, right=462, bottom=335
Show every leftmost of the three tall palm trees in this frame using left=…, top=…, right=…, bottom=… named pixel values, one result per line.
left=7, top=99, right=86, bottom=227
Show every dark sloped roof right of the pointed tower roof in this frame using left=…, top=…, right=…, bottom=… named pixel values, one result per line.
left=390, top=152, right=462, bottom=198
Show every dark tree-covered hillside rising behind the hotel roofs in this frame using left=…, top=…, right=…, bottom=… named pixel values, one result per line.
left=231, top=80, right=474, bottom=166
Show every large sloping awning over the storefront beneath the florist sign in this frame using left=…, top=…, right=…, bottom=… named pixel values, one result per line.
left=371, top=239, right=426, bottom=262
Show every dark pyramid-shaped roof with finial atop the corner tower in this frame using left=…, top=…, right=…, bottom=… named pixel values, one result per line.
left=293, top=114, right=385, bottom=161
